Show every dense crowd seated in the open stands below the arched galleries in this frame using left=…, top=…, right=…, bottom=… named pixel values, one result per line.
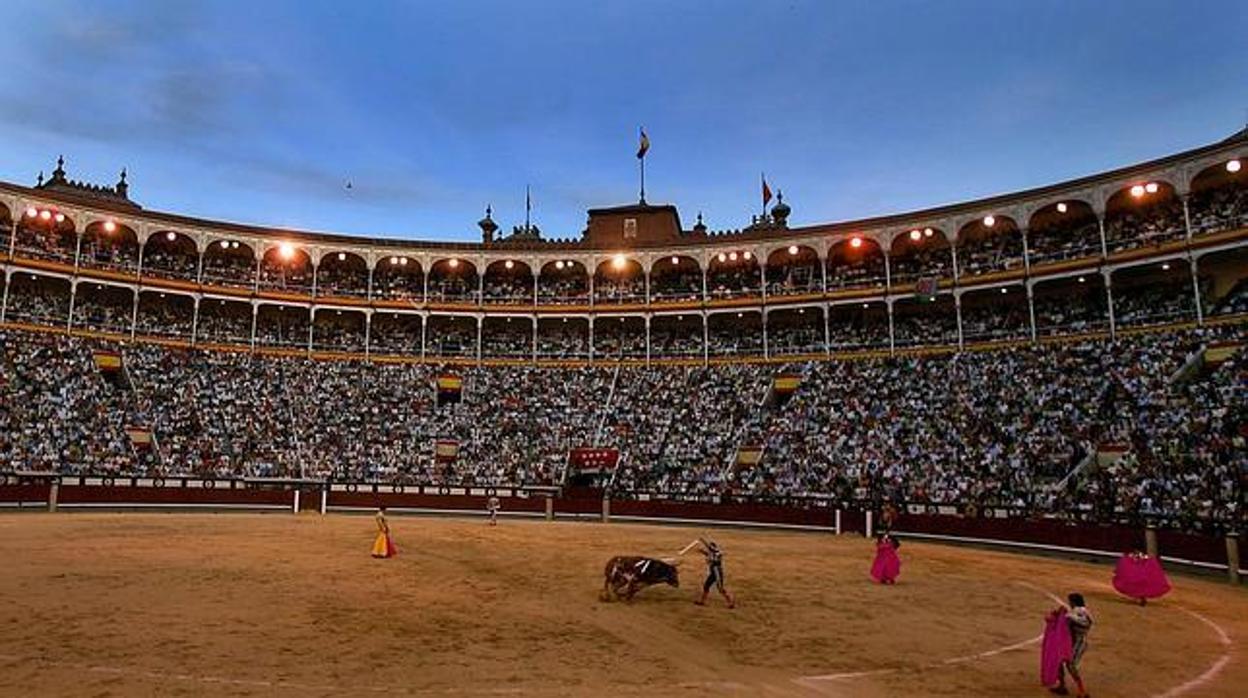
left=0, top=325, right=1248, bottom=529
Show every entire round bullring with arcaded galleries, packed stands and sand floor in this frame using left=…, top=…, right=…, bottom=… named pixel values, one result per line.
left=0, top=75, right=1248, bottom=698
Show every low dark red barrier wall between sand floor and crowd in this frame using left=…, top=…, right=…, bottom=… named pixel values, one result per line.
left=0, top=473, right=1248, bottom=578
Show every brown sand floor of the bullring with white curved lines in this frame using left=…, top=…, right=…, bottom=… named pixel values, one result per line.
left=0, top=513, right=1248, bottom=698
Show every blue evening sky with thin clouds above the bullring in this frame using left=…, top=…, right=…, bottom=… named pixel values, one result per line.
left=0, top=0, right=1248, bottom=240
